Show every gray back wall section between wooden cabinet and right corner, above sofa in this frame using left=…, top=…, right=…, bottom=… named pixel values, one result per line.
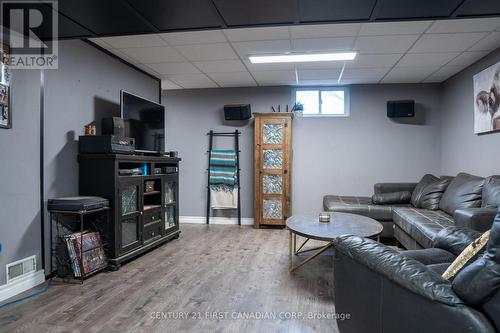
left=292, top=84, right=440, bottom=213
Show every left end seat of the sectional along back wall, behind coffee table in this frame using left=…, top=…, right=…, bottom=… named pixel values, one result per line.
left=323, top=195, right=408, bottom=221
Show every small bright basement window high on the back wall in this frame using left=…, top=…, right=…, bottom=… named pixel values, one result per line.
left=294, top=87, right=349, bottom=117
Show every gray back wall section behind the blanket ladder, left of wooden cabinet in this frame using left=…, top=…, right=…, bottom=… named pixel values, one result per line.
left=162, top=87, right=291, bottom=217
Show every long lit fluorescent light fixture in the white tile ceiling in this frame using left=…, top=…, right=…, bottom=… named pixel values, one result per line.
left=248, top=52, right=356, bottom=64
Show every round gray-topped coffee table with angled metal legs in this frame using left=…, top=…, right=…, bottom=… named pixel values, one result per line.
left=286, top=212, right=383, bottom=272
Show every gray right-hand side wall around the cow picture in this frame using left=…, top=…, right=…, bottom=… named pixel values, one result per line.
left=441, top=49, right=500, bottom=176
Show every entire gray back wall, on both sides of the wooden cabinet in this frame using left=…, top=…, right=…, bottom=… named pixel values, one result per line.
left=163, top=84, right=440, bottom=217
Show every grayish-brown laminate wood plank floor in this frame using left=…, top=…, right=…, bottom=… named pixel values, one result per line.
left=0, top=224, right=337, bottom=332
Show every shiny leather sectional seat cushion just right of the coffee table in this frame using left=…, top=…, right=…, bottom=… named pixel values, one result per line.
left=393, top=207, right=454, bottom=248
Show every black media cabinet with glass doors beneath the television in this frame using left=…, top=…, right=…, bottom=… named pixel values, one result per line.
left=78, top=154, right=181, bottom=269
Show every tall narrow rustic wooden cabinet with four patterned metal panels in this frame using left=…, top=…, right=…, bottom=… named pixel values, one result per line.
left=254, top=113, right=292, bottom=228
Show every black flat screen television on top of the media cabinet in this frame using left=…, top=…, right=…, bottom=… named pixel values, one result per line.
left=120, top=90, right=165, bottom=153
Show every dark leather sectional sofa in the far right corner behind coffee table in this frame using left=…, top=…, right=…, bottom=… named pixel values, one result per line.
left=323, top=173, right=500, bottom=249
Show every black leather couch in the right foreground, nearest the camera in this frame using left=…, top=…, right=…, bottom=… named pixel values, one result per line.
left=334, top=214, right=500, bottom=333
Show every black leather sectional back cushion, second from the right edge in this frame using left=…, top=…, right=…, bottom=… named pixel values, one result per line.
left=439, top=173, right=484, bottom=215
